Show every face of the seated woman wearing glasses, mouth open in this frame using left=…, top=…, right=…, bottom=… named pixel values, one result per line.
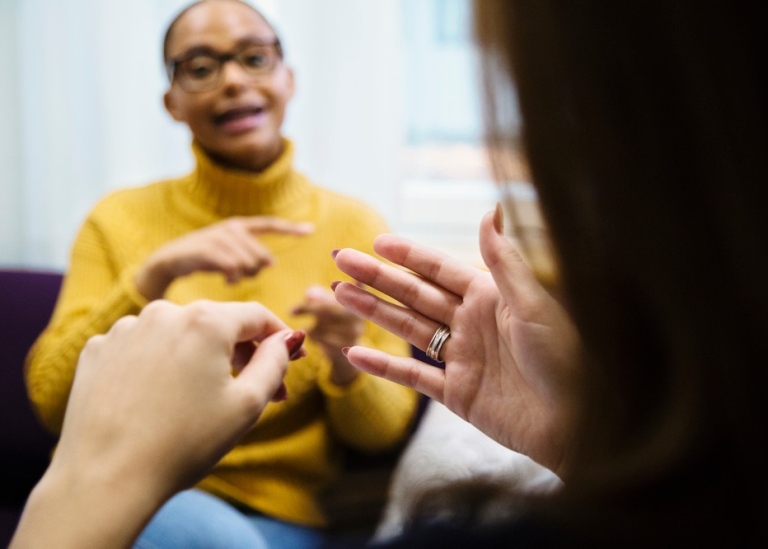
left=164, top=2, right=293, bottom=171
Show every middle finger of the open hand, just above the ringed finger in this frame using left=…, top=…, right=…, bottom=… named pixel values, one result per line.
left=335, top=247, right=461, bottom=323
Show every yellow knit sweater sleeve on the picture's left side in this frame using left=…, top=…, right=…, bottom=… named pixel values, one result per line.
left=25, top=206, right=146, bottom=433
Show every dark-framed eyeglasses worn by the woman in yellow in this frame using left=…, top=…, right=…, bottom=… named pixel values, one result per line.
left=166, top=38, right=283, bottom=93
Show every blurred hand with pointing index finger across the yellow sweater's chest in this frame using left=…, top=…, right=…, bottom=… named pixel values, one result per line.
left=135, top=217, right=313, bottom=301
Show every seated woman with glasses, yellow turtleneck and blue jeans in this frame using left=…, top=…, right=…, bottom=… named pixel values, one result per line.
left=27, top=0, right=417, bottom=548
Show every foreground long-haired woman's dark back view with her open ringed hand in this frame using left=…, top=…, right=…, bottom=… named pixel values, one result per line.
left=12, top=0, right=768, bottom=547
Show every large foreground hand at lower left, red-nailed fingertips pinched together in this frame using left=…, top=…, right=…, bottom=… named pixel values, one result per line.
left=12, top=301, right=304, bottom=548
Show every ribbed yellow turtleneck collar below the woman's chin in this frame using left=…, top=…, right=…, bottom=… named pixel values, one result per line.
left=184, top=138, right=309, bottom=217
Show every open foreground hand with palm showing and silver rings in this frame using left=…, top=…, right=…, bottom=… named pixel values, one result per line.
left=335, top=208, right=580, bottom=472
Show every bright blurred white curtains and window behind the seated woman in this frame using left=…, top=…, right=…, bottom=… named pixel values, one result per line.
left=0, top=0, right=531, bottom=269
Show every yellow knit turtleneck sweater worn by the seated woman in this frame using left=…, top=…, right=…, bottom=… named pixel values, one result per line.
left=26, top=140, right=417, bottom=526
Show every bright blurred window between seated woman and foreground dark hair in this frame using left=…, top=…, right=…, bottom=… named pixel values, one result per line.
left=398, top=0, right=536, bottom=264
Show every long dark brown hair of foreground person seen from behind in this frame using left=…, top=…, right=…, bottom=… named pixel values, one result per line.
left=476, top=0, right=768, bottom=540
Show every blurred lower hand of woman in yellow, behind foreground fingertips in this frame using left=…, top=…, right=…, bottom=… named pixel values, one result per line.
left=291, top=286, right=364, bottom=385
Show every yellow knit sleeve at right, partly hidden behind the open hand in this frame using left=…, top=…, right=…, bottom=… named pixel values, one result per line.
left=318, top=195, right=418, bottom=453
